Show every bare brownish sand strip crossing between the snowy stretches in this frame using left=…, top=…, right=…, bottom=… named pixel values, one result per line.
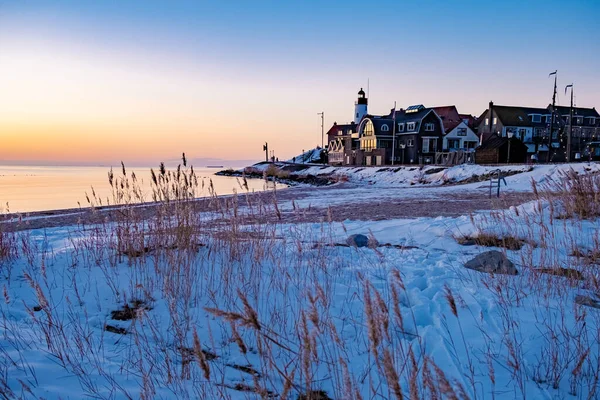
left=0, top=184, right=533, bottom=231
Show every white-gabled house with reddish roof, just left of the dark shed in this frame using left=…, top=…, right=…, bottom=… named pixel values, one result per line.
left=433, top=106, right=479, bottom=152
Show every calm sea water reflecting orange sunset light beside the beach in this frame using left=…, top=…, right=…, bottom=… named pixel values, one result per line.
left=0, top=166, right=284, bottom=212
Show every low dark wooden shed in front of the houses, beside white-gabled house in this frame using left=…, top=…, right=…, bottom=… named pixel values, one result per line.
left=475, top=133, right=527, bottom=164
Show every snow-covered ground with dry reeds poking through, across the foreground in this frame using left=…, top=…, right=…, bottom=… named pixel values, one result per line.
left=0, top=164, right=600, bottom=399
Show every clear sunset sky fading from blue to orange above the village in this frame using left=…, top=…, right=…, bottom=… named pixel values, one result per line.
left=0, top=0, right=600, bottom=165
